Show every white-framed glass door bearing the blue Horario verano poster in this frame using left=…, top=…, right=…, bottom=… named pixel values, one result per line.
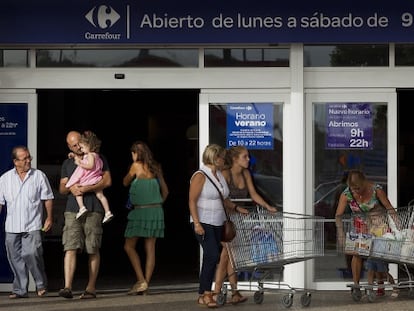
left=199, top=90, right=298, bottom=286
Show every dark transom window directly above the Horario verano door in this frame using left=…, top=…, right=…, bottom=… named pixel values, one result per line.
left=204, top=48, right=289, bottom=67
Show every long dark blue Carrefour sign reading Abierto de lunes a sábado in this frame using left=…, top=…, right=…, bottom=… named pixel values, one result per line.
left=0, top=0, right=414, bottom=44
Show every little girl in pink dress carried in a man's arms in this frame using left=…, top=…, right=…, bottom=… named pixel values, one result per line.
left=66, top=131, right=114, bottom=223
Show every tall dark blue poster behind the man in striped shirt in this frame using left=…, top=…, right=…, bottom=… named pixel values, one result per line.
left=0, top=103, right=28, bottom=283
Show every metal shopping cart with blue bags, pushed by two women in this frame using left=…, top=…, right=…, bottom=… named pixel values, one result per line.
left=217, top=205, right=324, bottom=308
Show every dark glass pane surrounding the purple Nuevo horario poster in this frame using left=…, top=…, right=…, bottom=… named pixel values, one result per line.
left=313, top=103, right=388, bottom=282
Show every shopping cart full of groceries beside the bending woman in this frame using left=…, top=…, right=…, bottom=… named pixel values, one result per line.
left=337, top=205, right=414, bottom=302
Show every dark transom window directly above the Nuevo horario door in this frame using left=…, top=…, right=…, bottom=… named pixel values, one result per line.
left=303, top=44, right=389, bottom=67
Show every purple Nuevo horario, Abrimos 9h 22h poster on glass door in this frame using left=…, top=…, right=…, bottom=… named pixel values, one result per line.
left=325, top=103, right=373, bottom=150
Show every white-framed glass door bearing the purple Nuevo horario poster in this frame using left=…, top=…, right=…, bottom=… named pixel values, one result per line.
left=306, top=90, right=397, bottom=289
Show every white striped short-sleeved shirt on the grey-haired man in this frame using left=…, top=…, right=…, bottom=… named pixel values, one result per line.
left=0, top=168, right=54, bottom=233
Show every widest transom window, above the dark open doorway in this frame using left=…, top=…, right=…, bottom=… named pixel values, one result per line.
left=36, top=49, right=198, bottom=68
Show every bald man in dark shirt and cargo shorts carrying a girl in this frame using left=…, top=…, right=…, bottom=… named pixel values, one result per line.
left=59, top=131, right=112, bottom=299
